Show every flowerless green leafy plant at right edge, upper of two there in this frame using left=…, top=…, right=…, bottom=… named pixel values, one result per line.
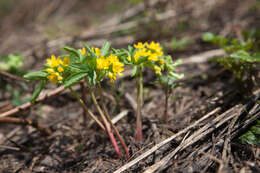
left=202, top=32, right=260, bottom=89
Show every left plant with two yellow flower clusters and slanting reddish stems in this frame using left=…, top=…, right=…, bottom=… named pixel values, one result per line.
left=24, top=42, right=130, bottom=158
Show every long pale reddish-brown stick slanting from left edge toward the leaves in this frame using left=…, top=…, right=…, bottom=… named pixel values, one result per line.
left=0, top=86, right=64, bottom=118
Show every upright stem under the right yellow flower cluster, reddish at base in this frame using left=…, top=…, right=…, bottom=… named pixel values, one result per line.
left=135, top=66, right=143, bottom=142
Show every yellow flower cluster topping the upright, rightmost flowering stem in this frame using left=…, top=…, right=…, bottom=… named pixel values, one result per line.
left=134, top=41, right=163, bottom=63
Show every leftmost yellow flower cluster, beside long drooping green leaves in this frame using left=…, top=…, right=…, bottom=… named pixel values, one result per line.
left=45, top=55, right=70, bottom=84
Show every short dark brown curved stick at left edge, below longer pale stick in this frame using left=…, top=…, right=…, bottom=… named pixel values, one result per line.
left=0, top=117, right=52, bottom=135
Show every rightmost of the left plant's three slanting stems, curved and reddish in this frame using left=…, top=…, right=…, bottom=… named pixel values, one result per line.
left=98, top=83, right=130, bottom=159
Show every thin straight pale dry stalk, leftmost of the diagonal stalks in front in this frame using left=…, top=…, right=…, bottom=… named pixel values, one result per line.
left=114, top=107, right=221, bottom=173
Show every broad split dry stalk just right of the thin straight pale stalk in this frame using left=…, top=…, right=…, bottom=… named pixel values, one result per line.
left=144, top=106, right=240, bottom=173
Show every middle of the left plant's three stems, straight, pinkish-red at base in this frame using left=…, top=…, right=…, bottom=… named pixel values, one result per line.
left=88, top=82, right=122, bottom=158
